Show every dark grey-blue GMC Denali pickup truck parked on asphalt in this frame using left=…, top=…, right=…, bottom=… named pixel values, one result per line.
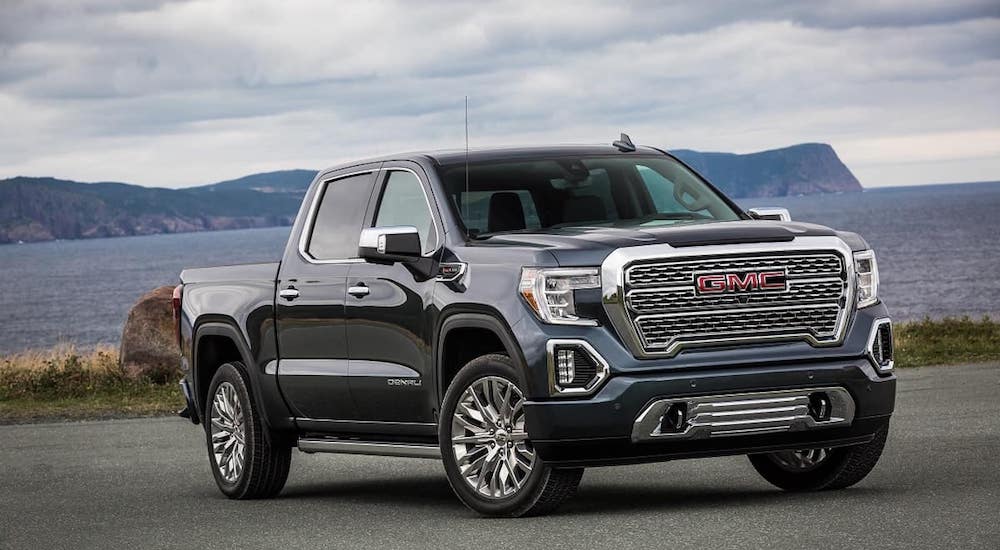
left=174, top=136, right=896, bottom=516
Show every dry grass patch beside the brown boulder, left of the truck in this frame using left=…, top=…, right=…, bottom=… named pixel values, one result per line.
left=0, top=346, right=184, bottom=424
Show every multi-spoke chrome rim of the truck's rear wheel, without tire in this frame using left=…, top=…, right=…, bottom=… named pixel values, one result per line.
left=212, top=382, right=246, bottom=483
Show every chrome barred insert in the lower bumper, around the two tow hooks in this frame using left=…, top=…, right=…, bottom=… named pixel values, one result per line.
left=632, top=387, right=855, bottom=442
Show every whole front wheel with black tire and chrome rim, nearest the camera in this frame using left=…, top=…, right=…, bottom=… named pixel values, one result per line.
left=438, top=355, right=583, bottom=517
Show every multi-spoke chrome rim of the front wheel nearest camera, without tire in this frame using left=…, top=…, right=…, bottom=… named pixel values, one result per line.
left=451, top=376, right=535, bottom=499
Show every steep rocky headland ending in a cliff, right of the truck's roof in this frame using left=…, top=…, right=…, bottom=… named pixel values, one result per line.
left=671, top=143, right=861, bottom=197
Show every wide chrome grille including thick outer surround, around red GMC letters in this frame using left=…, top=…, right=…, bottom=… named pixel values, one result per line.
left=601, top=236, right=856, bottom=358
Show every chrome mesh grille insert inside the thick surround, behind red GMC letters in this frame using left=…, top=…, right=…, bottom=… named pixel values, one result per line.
left=621, top=250, right=850, bottom=353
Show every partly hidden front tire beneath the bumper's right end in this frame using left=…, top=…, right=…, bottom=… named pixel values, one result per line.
left=748, top=427, right=889, bottom=491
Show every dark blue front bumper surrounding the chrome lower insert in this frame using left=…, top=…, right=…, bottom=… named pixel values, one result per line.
left=525, top=357, right=896, bottom=466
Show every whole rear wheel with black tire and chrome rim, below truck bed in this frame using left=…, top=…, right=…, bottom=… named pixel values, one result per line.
left=205, top=362, right=292, bottom=500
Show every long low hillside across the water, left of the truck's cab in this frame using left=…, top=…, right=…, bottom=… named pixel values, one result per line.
left=0, top=177, right=299, bottom=243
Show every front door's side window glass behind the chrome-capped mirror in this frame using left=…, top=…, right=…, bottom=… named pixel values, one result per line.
left=375, top=170, right=437, bottom=254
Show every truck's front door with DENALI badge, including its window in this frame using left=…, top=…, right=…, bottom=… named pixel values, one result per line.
left=347, top=163, right=442, bottom=424
